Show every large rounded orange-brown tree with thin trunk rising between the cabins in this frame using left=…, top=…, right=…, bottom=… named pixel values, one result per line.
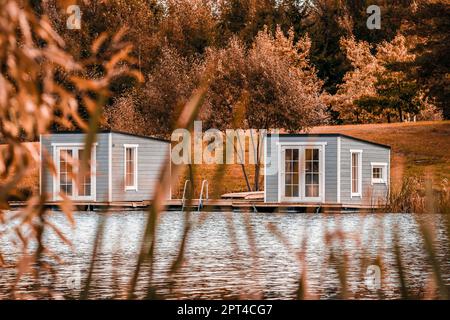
left=206, top=28, right=325, bottom=190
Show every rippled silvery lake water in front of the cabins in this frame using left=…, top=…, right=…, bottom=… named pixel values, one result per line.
left=0, top=211, right=450, bottom=299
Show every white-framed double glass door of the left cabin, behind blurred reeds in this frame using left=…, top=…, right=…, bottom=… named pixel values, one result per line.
left=54, top=146, right=95, bottom=200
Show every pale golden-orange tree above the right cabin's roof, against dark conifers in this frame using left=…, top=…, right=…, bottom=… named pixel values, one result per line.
left=328, top=35, right=434, bottom=123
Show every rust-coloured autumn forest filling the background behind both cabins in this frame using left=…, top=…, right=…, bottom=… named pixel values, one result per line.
left=30, top=0, right=450, bottom=137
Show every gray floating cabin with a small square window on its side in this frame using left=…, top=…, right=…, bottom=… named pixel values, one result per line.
left=264, top=134, right=390, bottom=208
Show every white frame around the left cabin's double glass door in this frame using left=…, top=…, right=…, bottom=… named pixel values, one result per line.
left=52, top=142, right=97, bottom=201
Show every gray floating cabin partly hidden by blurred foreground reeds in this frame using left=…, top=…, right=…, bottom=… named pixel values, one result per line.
left=40, top=131, right=170, bottom=204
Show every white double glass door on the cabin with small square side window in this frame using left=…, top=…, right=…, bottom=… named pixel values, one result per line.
left=281, top=146, right=323, bottom=201
